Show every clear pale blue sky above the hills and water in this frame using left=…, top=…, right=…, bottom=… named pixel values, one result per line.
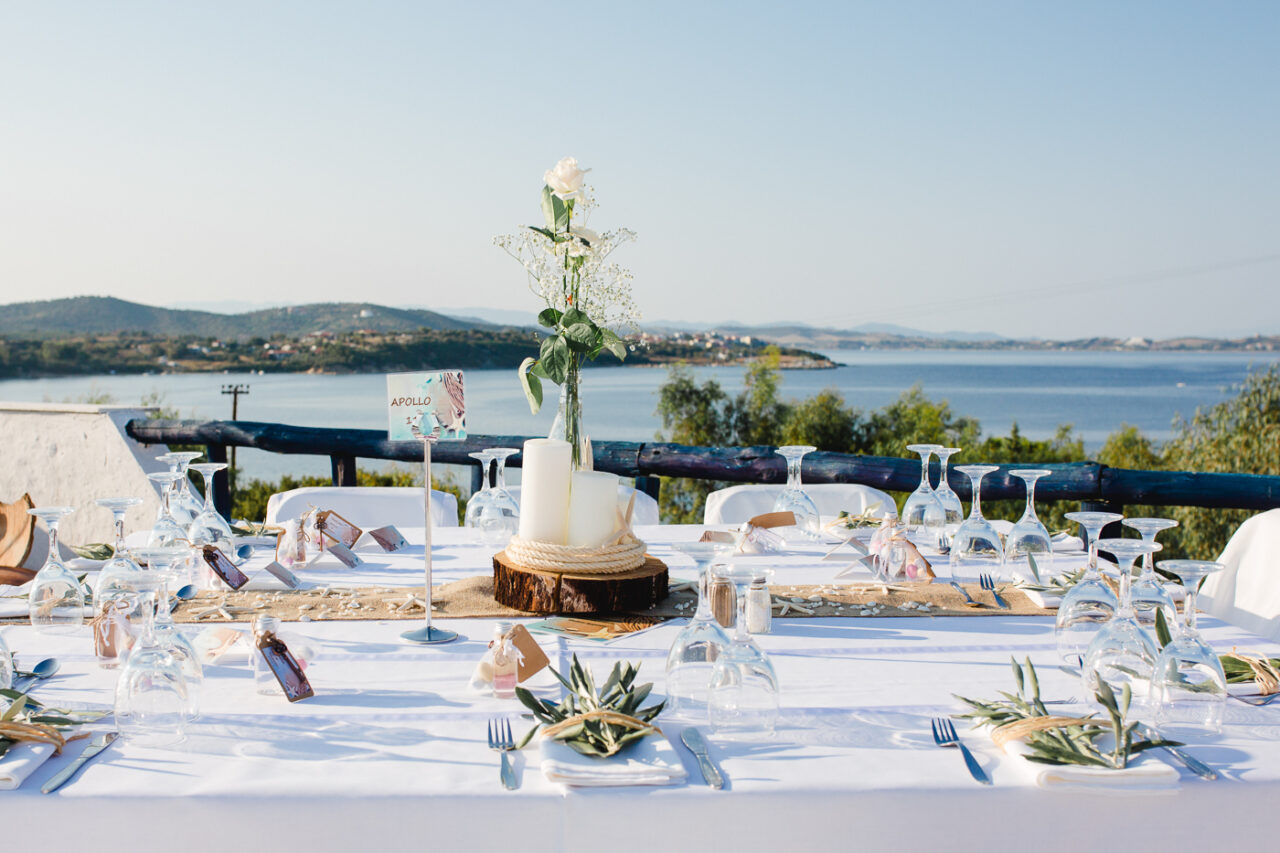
left=0, top=0, right=1280, bottom=338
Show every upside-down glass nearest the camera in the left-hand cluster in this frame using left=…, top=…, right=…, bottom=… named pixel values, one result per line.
left=115, top=588, right=188, bottom=747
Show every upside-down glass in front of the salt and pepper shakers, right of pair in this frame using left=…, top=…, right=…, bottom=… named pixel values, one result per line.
left=708, top=566, right=778, bottom=740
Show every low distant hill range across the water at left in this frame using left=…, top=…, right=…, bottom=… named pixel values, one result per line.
left=0, top=296, right=494, bottom=338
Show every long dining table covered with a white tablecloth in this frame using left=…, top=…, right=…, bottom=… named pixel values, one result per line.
left=0, top=525, right=1280, bottom=853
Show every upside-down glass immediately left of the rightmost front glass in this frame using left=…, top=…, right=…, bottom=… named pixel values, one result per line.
left=1080, top=539, right=1160, bottom=699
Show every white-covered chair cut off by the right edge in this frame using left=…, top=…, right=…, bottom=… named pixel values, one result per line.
left=1198, top=510, right=1280, bottom=640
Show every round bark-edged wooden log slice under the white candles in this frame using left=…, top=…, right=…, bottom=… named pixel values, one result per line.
left=493, top=551, right=667, bottom=613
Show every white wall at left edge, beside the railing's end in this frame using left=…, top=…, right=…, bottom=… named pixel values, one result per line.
left=0, top=402, right=169, bottom=553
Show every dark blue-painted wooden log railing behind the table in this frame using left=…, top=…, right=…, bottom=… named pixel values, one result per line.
left=125, top=420, right=1280, bottom=515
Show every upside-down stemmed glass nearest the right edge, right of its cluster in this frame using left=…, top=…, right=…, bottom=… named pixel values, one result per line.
left=1151, top=560, right=1226, bottom=736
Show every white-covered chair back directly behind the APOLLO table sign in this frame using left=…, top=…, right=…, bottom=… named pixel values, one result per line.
left=266, top=485, right=458, bottom=530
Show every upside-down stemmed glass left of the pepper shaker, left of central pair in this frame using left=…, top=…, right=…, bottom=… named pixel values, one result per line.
left=667, top=542, right=733, bottom=722
